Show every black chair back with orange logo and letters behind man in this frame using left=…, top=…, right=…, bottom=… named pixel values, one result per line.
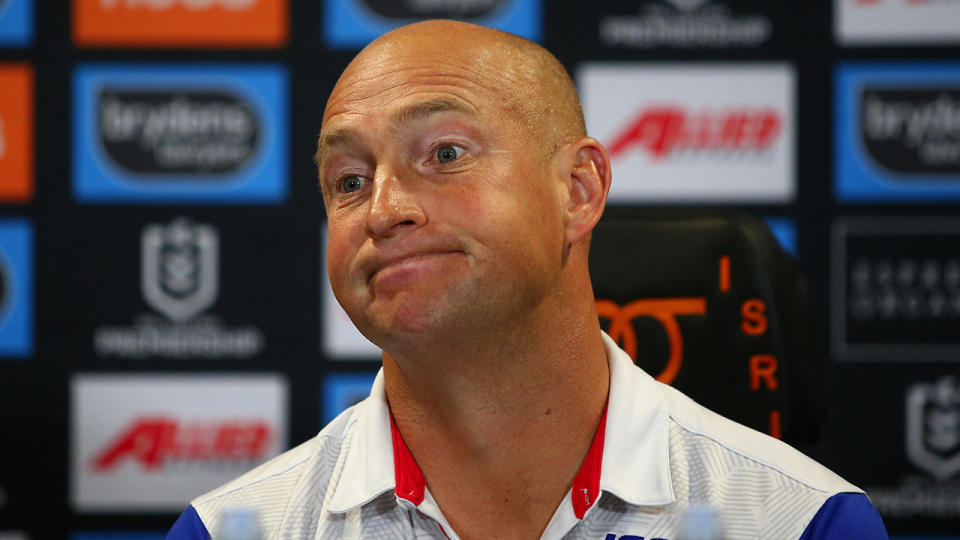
left=590, top=209, right=825, bottom=445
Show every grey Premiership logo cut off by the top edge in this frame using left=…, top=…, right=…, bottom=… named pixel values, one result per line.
left=598, top=0, right=773, bottom=49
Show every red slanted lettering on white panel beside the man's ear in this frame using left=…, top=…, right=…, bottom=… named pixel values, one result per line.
left=609, top=105, right=783, bottom=160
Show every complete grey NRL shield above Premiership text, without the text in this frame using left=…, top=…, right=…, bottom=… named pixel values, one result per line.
left=141, top=218, right=219, bottom=322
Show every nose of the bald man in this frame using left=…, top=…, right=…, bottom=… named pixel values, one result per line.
left=367, top=171, right=426, bottom=238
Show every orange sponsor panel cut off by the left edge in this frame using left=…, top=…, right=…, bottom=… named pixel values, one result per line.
left=0, top=63, right=33, bottom=202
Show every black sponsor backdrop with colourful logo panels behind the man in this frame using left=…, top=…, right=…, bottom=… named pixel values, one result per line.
left=0, top=0, right=960, bottom=540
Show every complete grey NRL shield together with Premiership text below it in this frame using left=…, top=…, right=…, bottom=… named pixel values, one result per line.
left=94, top=217, right=265, bottom=358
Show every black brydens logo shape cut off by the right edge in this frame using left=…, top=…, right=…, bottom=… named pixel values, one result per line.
left=859, top=86, right=960, bottom=175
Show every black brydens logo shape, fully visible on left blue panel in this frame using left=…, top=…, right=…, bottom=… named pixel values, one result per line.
left=97, top=89, right=261, bottom=175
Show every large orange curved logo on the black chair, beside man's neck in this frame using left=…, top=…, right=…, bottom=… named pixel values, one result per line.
left=597, top=297, right=707, bottom=384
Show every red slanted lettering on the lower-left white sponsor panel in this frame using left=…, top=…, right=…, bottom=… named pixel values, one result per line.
left=90, top=416, right=275, bottom=473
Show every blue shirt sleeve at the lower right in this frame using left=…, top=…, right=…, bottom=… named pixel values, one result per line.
left=800, top=493, right=889, bottom=540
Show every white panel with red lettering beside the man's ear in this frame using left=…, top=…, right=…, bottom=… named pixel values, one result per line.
left=578, top=64, right=795, bottom=202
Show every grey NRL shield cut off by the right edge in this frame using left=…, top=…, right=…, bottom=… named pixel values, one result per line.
left=906, top=376, right=960, bottom=481
